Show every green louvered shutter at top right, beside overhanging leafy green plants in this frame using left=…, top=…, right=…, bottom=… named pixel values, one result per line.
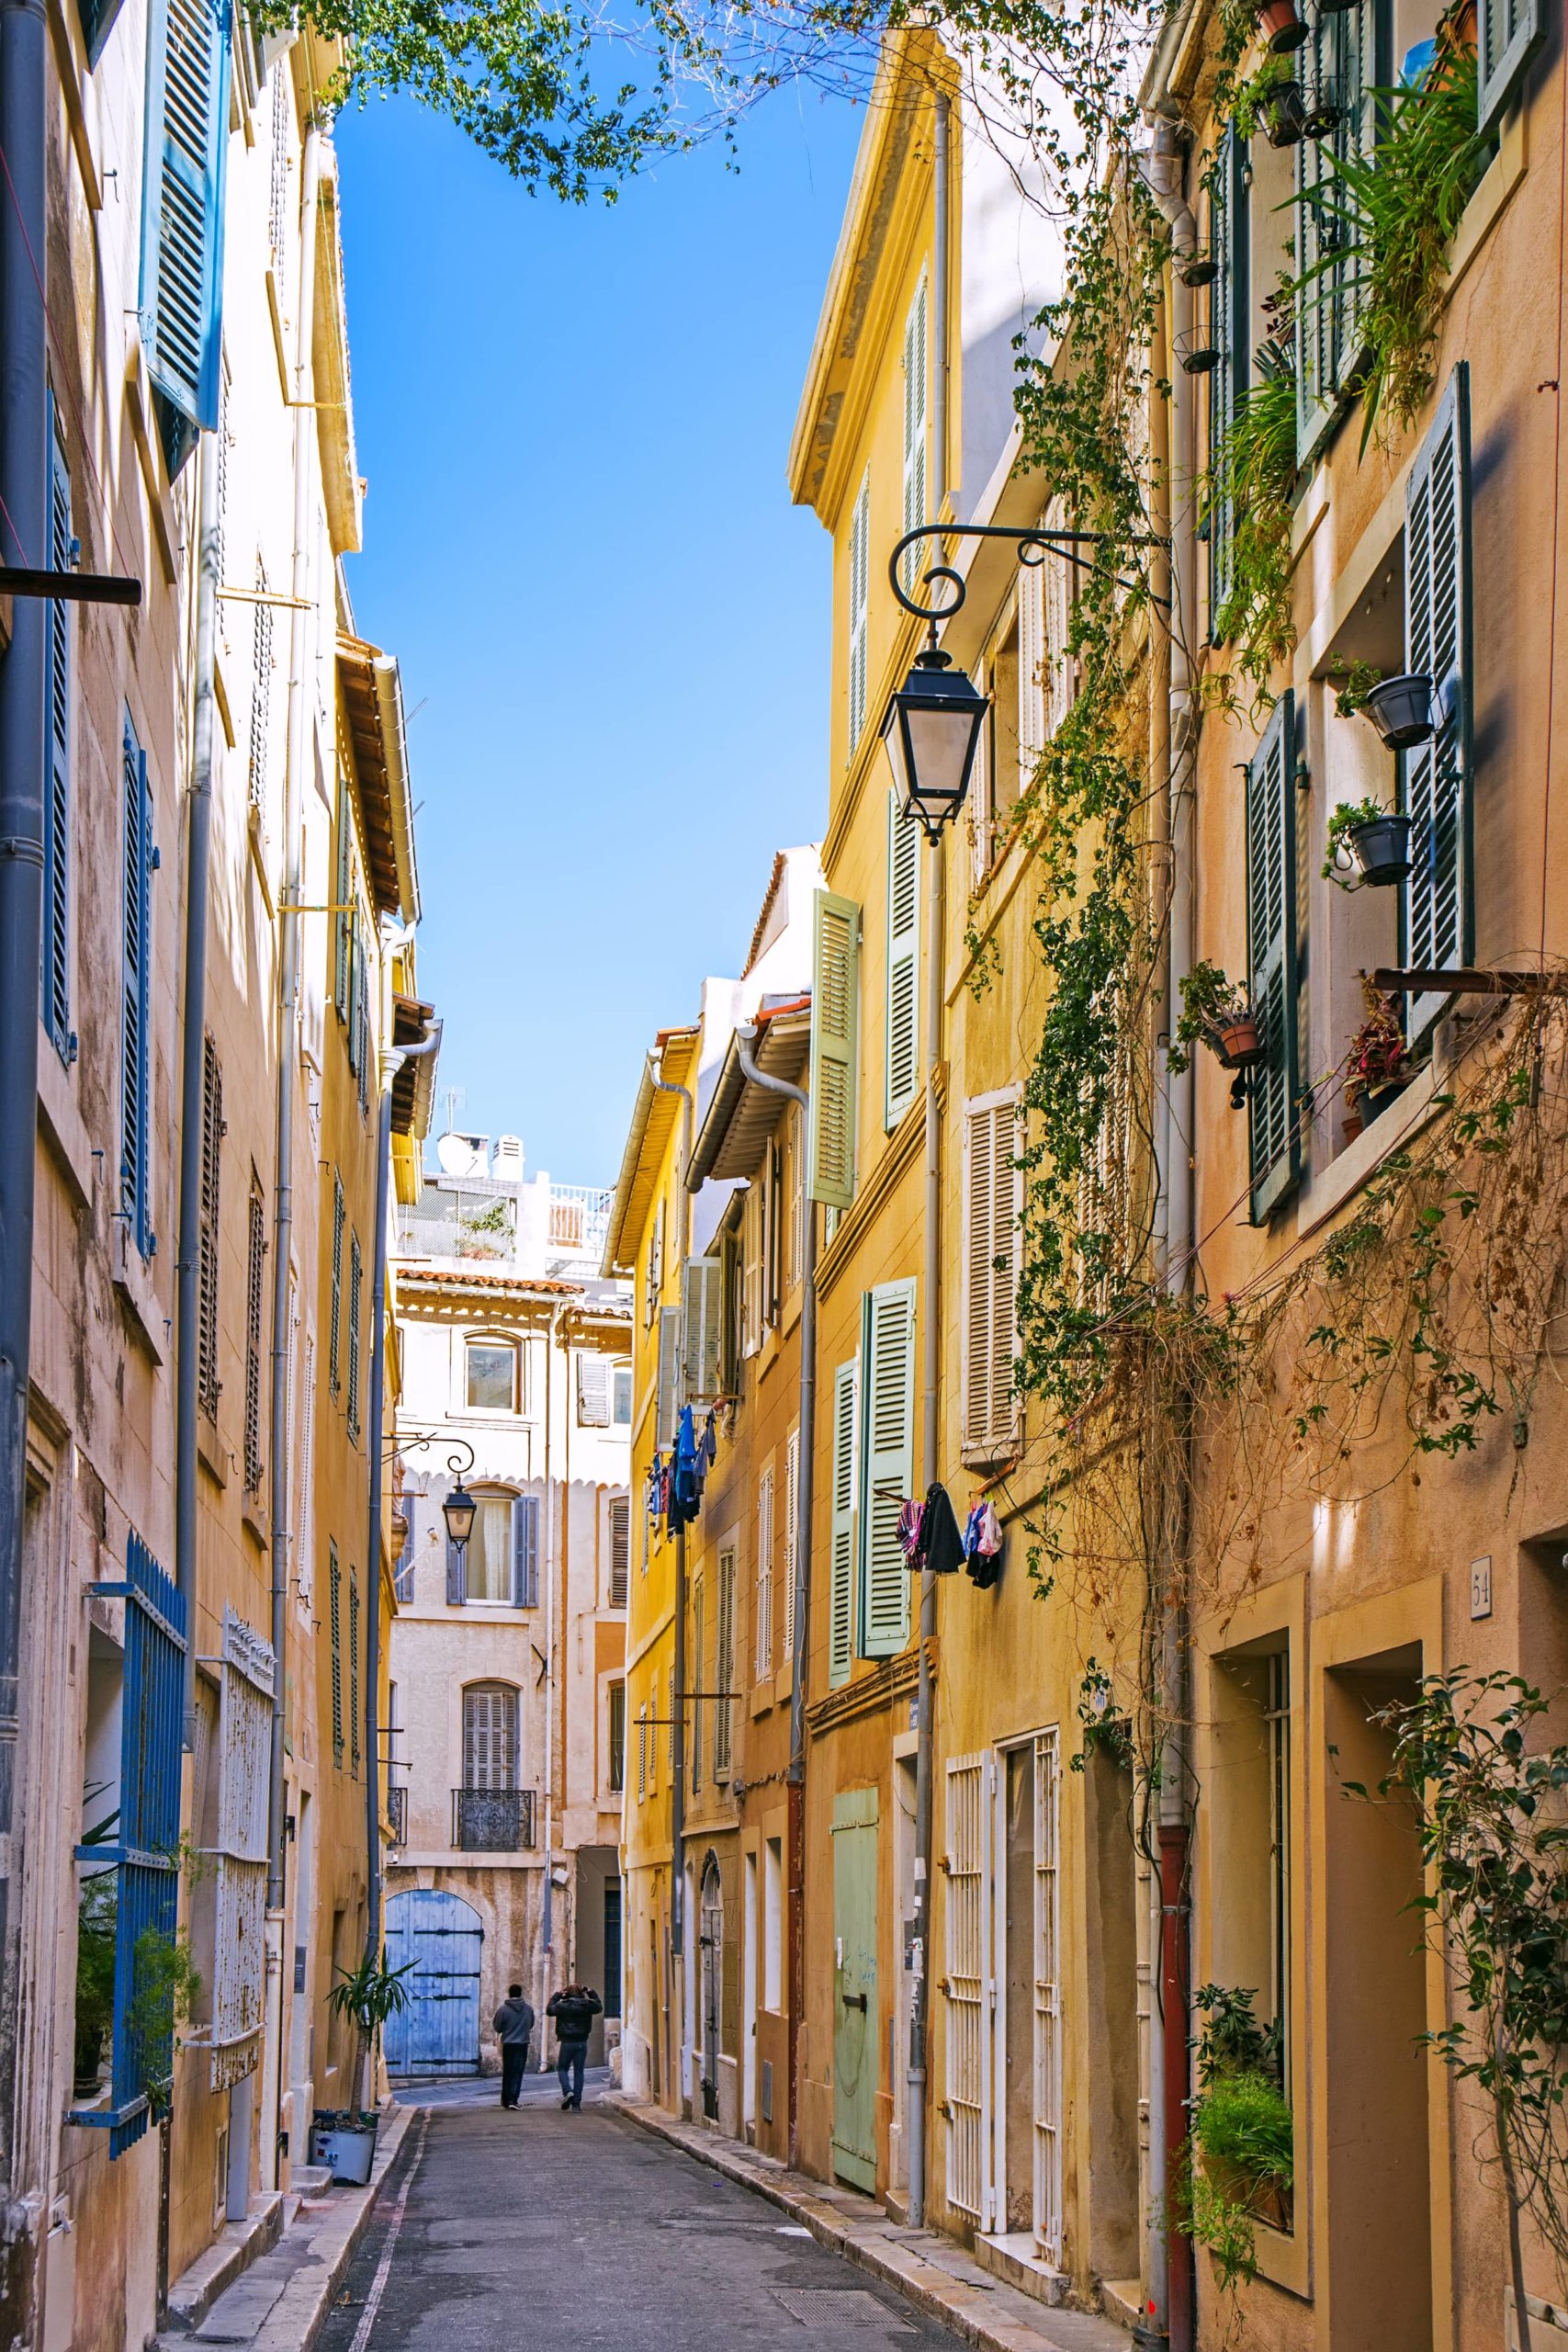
left=1295, top=0, right=1384, bottom=466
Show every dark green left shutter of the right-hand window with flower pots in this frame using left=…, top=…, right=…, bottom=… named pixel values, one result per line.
left=1246, top=694, right=1300, bottom=1226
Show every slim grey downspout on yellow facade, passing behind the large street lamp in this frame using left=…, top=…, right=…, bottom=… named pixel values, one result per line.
left=903, top=89, right=952, bottom=2230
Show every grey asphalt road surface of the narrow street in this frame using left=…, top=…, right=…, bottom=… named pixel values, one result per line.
left=317, top=2075, right=959, bottom=2352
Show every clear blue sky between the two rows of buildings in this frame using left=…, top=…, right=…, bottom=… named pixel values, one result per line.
left=339, top=92, right=861, bottom=1183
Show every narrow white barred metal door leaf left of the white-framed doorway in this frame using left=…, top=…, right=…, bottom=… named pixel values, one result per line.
left=942, top=1755, right=997, bottom=2227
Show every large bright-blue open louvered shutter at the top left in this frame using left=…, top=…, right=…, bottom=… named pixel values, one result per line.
left=141, top=0, right=228, bottom=473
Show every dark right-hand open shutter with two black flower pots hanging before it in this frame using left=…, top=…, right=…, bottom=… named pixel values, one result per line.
left=1401, top=360, right=1472, bottom=1040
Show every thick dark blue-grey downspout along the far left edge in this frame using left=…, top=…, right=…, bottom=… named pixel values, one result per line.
left=0, top=0, right=50, bottom=2257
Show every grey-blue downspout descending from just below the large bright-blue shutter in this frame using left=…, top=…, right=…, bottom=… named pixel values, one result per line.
left=174, top=433, right=221, bottom=1750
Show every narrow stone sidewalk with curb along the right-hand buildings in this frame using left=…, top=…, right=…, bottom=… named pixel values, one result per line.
left=600, top=2091, right=1131, bottom=2352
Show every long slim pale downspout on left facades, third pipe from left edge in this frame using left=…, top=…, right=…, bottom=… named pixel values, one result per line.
left=261, top=122, right=322, bottom=2189
